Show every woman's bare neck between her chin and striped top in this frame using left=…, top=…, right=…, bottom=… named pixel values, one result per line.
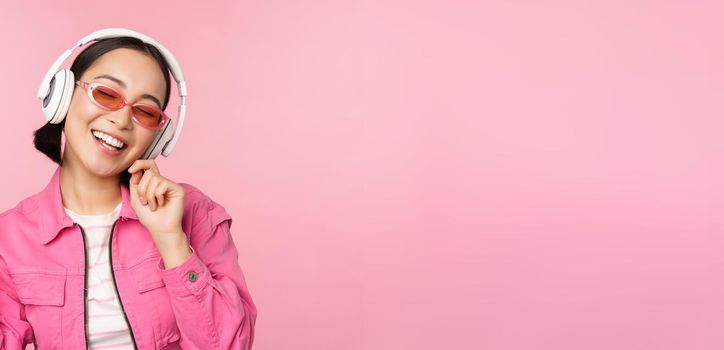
left=60, top=153, right=121, bottom=215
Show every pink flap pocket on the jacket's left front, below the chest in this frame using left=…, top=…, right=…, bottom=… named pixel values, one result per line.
left=10, top=271, right=66, bottom=349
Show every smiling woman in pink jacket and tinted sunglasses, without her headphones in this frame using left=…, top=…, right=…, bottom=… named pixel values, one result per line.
left=0, top=31, right=257, bottom=349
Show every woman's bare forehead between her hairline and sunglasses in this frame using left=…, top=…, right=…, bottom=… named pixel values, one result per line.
left=80, top=48, right=166, bottom=101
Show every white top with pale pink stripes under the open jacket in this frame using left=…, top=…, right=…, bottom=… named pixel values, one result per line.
left=64, top=203, right=133, bottom=349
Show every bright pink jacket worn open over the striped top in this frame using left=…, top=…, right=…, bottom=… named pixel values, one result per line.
left=0, top=167, right=257, bottom=350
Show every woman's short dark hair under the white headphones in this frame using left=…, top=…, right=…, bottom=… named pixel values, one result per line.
left=33, top=36, right=171, bottom=187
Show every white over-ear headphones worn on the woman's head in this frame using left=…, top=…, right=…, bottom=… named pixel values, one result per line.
left=38, top=28, right=186, bottom=159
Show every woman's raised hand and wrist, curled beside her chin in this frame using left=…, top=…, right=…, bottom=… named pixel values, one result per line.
left=128, top=159, right=191, bottom=268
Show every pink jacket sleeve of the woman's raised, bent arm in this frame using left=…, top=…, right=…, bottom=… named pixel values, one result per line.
left=159, top=194, right=257, bottom=350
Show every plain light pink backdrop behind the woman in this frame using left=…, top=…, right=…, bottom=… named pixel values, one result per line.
left=0, top=0, right=724, bottom=350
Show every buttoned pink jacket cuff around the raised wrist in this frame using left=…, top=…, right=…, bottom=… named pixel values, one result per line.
left=158, top=247, right=210, bottom=296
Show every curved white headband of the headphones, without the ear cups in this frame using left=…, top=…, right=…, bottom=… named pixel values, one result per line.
left=37, top=28, right=187, bottom=156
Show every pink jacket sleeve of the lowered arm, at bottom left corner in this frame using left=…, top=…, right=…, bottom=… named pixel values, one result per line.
left=0, top=257, right=33, bottom=350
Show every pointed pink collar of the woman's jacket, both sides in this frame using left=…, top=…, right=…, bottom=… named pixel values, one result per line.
left=37, top=166, right=138, bottom=244
